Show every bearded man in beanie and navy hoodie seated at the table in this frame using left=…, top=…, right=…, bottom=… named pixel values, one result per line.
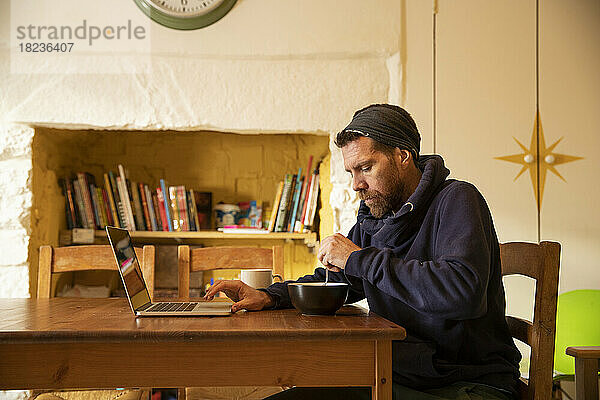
left=206, top=104, right=521, bottom=400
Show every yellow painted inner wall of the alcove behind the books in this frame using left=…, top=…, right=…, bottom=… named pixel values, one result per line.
left=30, top=128, right=329, bottom=294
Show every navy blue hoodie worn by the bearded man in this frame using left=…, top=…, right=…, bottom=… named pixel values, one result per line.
left=266, top=155, right=521, bottom=394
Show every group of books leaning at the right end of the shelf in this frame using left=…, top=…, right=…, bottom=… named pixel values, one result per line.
left=269, top=156, right=319, bottom=233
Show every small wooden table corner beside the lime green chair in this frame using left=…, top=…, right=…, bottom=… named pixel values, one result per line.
left=567, top=346, right=600, bottom=400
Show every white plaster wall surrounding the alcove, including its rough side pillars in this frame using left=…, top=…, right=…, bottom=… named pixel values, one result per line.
left=0, top=0, right=431, bottom=296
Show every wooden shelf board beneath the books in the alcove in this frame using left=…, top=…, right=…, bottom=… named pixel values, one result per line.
left=59, top=230, right=318, bottom=248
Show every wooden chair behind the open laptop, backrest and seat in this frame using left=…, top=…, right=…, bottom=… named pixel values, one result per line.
left=31, top=245, right=154, bottom=400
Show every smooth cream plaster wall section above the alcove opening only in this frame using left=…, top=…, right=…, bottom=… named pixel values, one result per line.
left=0, top=0, right=401, bottom=133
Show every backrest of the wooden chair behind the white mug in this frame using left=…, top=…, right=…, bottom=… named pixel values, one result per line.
left=177, top=246, right=283, bottom=298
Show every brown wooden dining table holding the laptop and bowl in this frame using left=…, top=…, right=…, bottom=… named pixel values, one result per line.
left=0, top=298, right=406, bottom=399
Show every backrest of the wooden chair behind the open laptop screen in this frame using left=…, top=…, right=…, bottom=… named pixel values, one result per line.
left=37, top=245, right=154, bottom=298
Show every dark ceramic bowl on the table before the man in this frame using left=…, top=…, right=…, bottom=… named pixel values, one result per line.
left=288, top=282, right=349, bottom=315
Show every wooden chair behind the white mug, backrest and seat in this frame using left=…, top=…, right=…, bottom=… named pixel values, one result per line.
left=177, top=246, right=284, bottom=400
